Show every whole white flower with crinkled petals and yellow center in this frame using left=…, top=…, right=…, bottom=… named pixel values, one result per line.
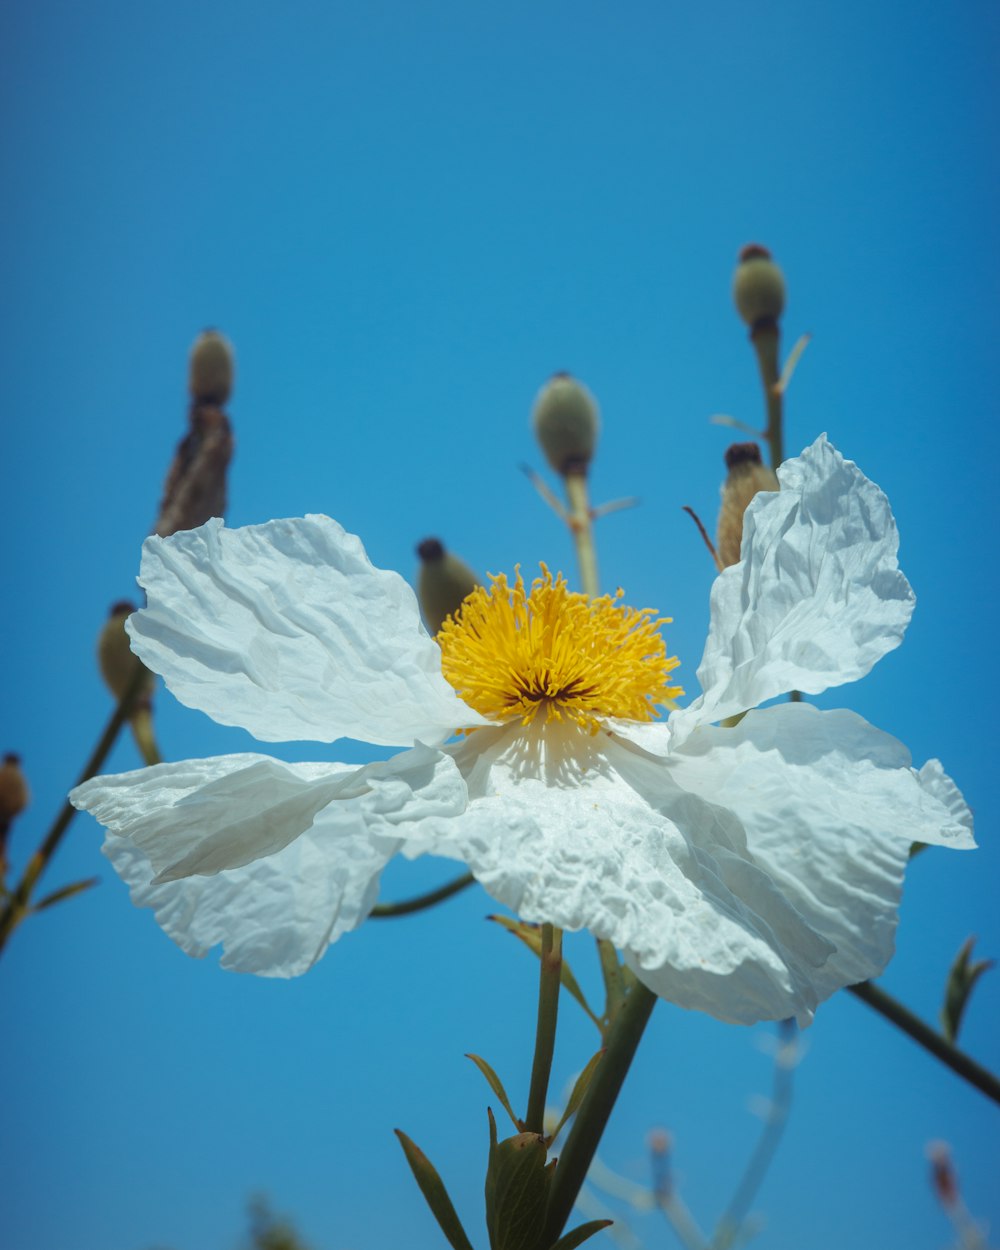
left=71, top=438, right=974, bottom=1023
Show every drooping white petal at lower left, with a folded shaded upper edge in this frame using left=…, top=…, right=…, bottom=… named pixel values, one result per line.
left=71, top=746, right=466, bottom=976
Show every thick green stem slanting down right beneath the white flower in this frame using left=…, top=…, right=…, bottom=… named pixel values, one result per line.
left=543, top=981, right=656, bottom=1245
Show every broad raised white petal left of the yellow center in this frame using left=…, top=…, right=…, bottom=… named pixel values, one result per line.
left=128, top=516, right=485, bottom=746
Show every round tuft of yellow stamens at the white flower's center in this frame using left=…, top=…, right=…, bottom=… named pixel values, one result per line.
left=438, top=565, right=684, bottom=733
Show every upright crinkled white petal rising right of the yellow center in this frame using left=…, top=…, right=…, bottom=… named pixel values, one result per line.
left=671, top=435, right=914, bottom=735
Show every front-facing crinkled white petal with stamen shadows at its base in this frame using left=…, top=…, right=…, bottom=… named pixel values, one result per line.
left=401, top=726, right=834, bottom=1023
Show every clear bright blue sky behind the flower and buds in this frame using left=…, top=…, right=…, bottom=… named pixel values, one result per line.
left=0, top=0, right=1000, bottom=1250
